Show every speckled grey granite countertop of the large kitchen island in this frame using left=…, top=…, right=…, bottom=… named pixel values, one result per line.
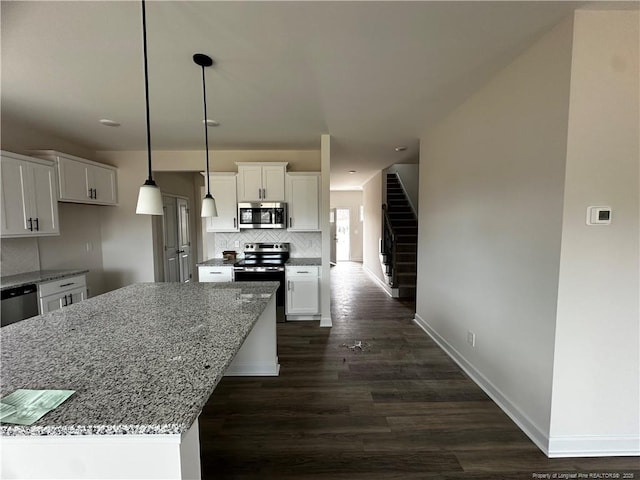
left=0, top=282, right=278, bottom=436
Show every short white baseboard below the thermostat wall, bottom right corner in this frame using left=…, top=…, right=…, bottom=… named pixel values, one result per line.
left=548, top=435, right=640, bottom=458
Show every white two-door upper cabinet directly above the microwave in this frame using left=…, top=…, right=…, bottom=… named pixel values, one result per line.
left=237, top=162, right=287, bottom=202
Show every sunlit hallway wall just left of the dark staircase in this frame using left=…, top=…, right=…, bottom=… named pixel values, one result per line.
left=362, top=173, right=385, bottom=283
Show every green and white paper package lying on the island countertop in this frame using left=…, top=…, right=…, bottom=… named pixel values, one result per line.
left=0, top=389, right=76, bottom=425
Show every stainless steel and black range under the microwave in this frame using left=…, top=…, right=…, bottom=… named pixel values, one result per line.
left=233, top=243, right=289, bottom=322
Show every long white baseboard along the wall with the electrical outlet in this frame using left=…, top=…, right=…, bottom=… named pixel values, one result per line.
left=413, top=313, right=549, bottom=456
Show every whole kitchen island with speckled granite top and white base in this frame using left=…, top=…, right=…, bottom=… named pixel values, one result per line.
left=0, top=282, right=279, bottom=479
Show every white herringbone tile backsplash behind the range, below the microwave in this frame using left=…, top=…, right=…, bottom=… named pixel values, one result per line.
left=206, top=229, right=322, bottom=258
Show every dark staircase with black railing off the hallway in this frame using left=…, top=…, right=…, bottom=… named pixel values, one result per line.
left=380, top=173, right=418, bottom=298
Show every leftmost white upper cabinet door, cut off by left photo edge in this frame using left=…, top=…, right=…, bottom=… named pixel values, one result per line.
left=0, top=156, right=31, bottom=237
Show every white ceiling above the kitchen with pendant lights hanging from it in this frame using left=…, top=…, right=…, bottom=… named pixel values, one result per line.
left=1, top=1, right=579, bottom=189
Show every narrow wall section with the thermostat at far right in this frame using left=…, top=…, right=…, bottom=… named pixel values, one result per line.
left=550, top=11, right=640, bottom=455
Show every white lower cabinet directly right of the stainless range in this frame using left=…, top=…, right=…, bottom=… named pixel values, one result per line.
left=285, top=266, right=320, bottom=320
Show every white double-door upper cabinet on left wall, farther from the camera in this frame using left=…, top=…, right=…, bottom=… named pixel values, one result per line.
left=36, top=150, right=118, bottom=205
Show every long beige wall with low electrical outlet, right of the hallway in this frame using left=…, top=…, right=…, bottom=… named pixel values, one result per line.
left=416, top=15, right=572, bottom=447
